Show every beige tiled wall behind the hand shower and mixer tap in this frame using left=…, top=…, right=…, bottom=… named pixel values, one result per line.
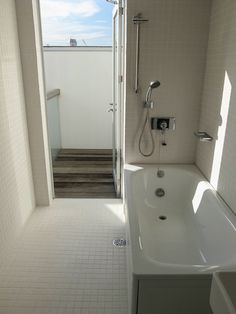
left=125, top=0, right=211, bottom=163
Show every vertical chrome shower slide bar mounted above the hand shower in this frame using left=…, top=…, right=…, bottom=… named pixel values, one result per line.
left=133, top=13, right=148, bottom=94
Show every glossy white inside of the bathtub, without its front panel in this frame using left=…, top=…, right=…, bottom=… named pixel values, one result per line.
left=126, top=165, right=236, bottom=268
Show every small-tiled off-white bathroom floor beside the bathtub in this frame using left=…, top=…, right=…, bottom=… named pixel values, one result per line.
left=0, top=199, right=127, bottom=314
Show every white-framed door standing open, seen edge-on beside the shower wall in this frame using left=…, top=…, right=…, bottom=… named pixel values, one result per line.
left=112, top=1, right=124, bottom=196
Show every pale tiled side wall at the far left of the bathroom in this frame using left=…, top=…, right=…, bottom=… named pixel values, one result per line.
left=0, top=0, right=34, bottom=255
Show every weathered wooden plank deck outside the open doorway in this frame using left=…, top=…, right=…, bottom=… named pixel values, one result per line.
left=53, top=149, right=116, bottom=198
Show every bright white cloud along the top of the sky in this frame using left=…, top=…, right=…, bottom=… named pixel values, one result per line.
left=41, top=0, right=100, bottom=19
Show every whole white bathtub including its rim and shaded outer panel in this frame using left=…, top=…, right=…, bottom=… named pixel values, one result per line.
left=125, top=165, right=236, bottom=314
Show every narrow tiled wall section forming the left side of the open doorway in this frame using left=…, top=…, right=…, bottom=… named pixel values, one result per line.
left=15, top=0, right=52, bottom=205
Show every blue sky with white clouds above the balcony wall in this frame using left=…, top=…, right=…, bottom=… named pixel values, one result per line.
left=40, top=0, right=113, bottom=46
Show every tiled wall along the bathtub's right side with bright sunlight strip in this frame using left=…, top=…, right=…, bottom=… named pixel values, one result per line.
left=196, top=0, right=236, bottom=212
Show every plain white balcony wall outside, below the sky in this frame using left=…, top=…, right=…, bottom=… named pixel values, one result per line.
left=44, top=48, right=112, bottom=148
